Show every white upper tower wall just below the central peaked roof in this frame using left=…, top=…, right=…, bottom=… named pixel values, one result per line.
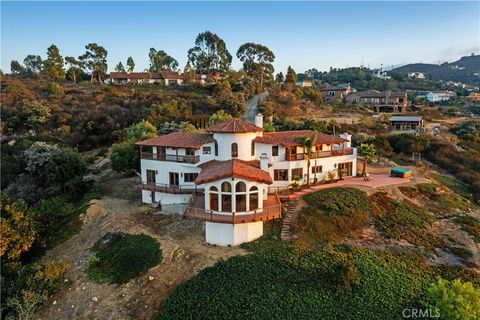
left=213, top=132, right=258, bottom=161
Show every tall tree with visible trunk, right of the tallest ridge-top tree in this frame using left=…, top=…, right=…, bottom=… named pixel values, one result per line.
left=237, top=42, right=275, bottom=92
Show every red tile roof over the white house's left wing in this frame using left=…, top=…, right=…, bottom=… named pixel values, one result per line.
left=136, top=132, right=214, bottom=149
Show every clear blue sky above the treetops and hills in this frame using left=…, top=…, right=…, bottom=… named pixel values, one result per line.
left=0, top=0, right=480, bottom=73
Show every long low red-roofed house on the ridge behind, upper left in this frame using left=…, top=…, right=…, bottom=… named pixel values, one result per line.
left=110, top=71, right=186, bottom=85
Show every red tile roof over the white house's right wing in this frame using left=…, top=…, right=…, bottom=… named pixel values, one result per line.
left=255, top=130, right=347, bottom=147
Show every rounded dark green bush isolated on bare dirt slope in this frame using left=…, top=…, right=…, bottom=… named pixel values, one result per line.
left=87, top=233, right=162, bottom=283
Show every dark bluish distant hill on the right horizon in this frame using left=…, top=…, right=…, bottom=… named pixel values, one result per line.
left=391, top=55, right=480, bottom=84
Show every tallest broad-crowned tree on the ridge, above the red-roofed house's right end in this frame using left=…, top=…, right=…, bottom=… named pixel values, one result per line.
left=188, top=31, right=232, bottom=74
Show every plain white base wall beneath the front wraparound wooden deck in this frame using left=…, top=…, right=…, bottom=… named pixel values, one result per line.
left=205, top=221, right=263, bottom=246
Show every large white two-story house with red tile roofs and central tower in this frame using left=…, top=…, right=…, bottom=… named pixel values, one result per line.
left=137, top=115, right=357, bottom=245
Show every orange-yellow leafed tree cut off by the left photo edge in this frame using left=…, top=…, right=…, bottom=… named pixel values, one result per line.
left=0, top=192, right=35, bottom=262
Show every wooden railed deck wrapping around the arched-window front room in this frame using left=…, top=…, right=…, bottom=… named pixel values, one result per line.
left=185, top=192, right=282, bottom=224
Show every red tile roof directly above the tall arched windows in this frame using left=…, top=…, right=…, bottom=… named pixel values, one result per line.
left=195, top=159, right=273, bottom=184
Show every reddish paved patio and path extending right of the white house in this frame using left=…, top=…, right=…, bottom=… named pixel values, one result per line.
left=288, top=174, right=411, bottom=200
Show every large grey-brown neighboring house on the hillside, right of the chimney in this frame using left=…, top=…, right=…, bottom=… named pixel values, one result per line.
left=345, top=90, right=410, bottom=113
